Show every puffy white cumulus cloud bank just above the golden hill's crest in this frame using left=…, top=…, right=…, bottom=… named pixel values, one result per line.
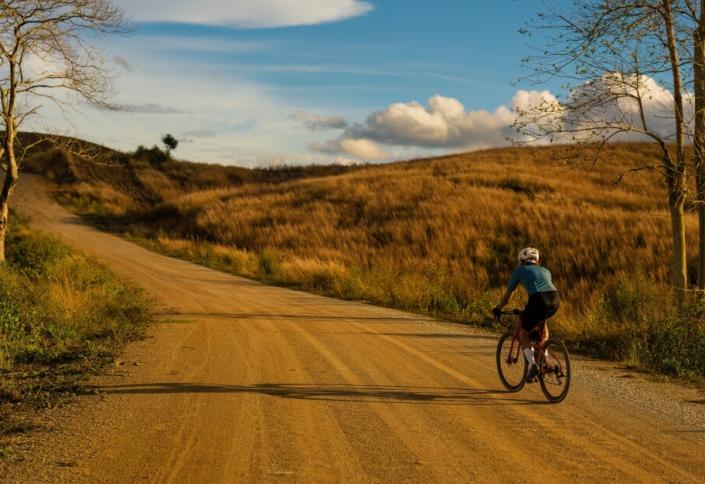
left=309, top=74, right=693, bottom=160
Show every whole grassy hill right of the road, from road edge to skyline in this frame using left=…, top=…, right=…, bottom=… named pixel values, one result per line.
left=26, top=138, right=705, bottom=372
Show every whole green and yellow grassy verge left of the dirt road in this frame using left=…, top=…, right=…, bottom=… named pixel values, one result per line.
left=0, top=218, right=150, bottom=455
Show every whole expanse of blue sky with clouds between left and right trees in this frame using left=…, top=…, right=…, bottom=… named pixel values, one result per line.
left=34, top=0, right=556, bottom=166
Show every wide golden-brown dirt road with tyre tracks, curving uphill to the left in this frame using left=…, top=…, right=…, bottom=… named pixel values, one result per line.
left=0, top=177, right=705, bottom=483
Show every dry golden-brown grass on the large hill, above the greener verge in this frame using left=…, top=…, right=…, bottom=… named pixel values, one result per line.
left=144, top=145, right=680, bottom=312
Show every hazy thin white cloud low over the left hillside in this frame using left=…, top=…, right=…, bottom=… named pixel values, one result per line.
left=26, top=33, right=310, bottom=166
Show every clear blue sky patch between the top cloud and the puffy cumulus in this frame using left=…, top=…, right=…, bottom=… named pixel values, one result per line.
left=132, top=0, right=533, bottom=109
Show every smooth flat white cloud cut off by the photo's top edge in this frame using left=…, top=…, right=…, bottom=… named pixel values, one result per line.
left=115, top=0, right=373, bottom=28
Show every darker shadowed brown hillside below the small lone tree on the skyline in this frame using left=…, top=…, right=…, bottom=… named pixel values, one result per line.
left=18, top=133, right=355, bottom=214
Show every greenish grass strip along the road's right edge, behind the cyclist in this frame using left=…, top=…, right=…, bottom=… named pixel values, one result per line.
left=123, top=233, right=705, bottom=380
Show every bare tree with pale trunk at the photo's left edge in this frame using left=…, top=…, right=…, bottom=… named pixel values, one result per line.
left=0, top=0, right=125, bottom=262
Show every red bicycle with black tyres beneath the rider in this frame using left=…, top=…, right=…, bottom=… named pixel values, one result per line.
left=497, top=309, right=570, bottom=403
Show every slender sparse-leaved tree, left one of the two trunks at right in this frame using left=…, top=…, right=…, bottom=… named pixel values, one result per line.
left=516, top=0, right=692, bottom=303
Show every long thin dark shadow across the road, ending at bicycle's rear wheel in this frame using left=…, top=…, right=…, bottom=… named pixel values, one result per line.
left=92, top=383, right=546, bottom=405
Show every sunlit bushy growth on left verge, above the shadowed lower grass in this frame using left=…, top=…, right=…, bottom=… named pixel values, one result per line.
left=0, top=225, right=148, bottom=370
